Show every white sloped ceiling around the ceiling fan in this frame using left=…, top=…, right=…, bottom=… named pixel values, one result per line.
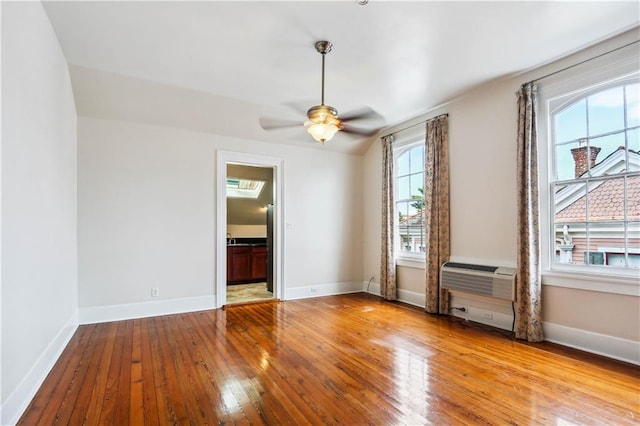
left=44, top=0, right=640, bottom=152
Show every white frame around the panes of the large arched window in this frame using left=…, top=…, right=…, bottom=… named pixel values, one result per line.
left=537, top=46, right=640, bottom=296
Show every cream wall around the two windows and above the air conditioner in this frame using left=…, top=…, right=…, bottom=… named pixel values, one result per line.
left=363, top=30, right=640, bottom=363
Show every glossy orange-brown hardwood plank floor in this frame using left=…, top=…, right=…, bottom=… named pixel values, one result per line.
left=19, top=294, right=640, bottom=425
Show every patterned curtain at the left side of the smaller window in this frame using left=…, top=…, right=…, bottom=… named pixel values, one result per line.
left=380, top=135, right=396, bottom=300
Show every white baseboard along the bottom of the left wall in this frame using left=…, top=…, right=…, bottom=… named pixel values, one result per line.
left=0, top=311, right=78, bottom=425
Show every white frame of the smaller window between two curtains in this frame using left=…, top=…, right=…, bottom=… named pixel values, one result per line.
left=393, top=133, right=426, bottom=268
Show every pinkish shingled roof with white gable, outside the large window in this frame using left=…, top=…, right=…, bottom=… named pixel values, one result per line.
left=555, top=147, right=640, bottom=222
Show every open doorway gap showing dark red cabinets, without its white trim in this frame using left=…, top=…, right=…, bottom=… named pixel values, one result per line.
left=226, top=164, right=274, bottom=305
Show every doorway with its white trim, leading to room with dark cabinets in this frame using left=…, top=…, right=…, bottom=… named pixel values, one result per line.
left=215, top=151, right=284, bottom=307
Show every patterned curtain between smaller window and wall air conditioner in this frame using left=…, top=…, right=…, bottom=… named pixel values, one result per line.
left=424, top=115, right=450, bottom=314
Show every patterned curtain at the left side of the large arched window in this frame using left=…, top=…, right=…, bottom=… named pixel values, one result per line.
left=515, top=83, right=544, bottom=342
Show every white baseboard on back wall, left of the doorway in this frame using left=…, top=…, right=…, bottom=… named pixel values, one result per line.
left=78, top=296, right=216, bottom=324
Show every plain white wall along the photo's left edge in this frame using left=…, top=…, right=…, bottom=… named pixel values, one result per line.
left=1, top=2, right=78, bottom=424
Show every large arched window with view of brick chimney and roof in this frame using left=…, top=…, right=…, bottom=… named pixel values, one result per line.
left=540, top=46, right=640, bottom=277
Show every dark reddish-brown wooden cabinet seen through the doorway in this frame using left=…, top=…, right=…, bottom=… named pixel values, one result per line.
left=227, top=246, right=267, bottom=284
